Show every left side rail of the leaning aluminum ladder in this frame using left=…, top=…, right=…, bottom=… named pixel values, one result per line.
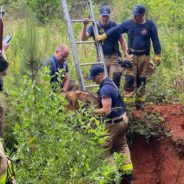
left=61, top=0, right=85, bottom=91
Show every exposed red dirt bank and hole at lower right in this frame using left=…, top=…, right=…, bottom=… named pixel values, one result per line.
left=131, top=105, right=184, bottom=184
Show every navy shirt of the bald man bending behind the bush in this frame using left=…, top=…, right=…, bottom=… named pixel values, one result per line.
left=47, top=56, right=68, bottom=87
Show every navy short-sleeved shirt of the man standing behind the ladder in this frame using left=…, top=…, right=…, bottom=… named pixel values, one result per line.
left=87, top=20, right=121, bottom=55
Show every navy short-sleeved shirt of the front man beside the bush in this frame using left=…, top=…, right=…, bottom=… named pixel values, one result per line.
left=99, top=78, right=125, bottom=119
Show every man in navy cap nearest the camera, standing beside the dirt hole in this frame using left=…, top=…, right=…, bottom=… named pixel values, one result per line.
left=90, top=65, right=133, bottom=184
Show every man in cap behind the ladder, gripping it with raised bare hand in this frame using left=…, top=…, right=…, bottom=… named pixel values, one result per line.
left=81, top=5, right=127, bottom=88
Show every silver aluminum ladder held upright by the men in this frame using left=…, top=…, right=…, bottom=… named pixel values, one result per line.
left=61, top=0, right=107, bottom=91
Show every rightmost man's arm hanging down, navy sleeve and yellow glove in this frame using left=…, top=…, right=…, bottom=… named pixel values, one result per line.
left=150, top=23, right=162, bottom=65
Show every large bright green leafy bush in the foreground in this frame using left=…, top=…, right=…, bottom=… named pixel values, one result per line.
left=3, top=68, right=126, bottom=184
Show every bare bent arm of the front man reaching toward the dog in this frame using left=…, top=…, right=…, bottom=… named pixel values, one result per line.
left=94, top=98, right=112, bottom=115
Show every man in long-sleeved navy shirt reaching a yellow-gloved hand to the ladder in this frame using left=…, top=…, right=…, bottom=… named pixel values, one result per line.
left=96, top=4, right=161, bottom=109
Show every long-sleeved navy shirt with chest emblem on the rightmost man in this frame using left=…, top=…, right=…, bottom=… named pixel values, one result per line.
left=106, top=19, right=161, bottom=55
